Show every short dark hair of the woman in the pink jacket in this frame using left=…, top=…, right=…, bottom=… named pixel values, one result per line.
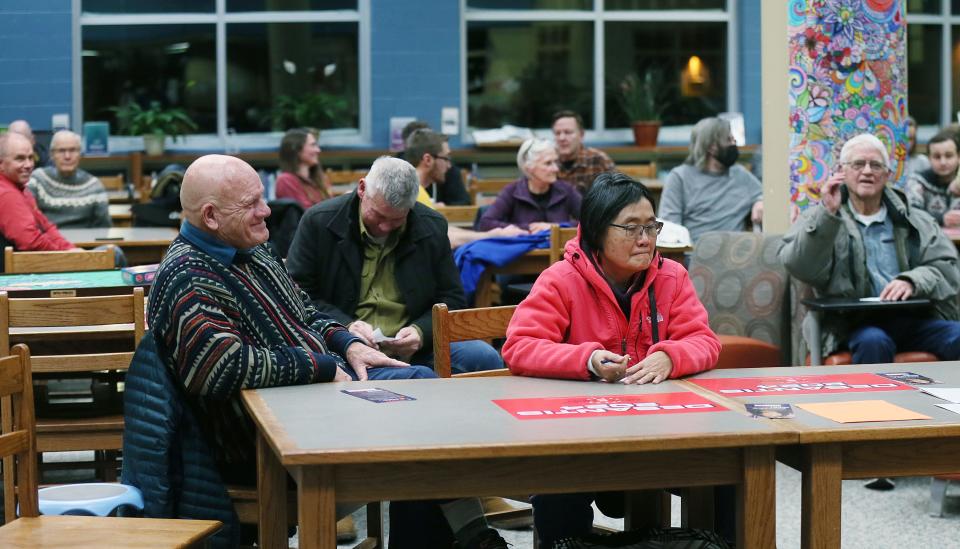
left=580, top=172, right=657, bottom=251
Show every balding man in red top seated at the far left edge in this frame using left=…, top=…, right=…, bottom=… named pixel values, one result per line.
left=0, top=132, right=76, bottom=267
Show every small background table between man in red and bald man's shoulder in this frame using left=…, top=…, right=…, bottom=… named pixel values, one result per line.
left=60, top=227, right=178, bottom=265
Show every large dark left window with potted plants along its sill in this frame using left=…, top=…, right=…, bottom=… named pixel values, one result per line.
left=74, top=0, right=369, bottom=144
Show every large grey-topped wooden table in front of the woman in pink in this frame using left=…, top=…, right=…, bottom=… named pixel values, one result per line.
left=243, top=377, right=796, bottom=549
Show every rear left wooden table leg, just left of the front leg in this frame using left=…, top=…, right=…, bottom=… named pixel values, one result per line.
left=257, top=432, right=289, bottom=549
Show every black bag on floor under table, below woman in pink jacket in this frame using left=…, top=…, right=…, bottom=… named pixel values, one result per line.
left=553, top=527, right=731, bottom=549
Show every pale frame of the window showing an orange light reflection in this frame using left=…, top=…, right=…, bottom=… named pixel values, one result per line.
left=460, top=0, right=742, bottom=144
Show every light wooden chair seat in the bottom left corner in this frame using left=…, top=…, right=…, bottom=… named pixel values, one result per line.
left=0, top=515, right=221, bottom=549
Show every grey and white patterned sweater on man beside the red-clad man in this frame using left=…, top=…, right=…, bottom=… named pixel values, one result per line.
left=27, top=166, right=110, bottom=229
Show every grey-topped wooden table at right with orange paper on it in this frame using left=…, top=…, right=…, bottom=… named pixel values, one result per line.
left=696, top=362, right=960, bottom=549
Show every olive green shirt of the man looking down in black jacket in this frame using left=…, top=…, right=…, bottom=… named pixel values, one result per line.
left=355, top=206, right=423, bottom=341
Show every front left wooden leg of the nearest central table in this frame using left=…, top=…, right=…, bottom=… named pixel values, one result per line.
left=297, top=467, right=337, bottom=549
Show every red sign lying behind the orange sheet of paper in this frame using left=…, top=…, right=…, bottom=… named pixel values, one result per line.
left=689, top=374, right=915, bottom=396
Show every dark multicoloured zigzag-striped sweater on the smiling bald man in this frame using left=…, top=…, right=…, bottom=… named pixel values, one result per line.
left=149, top=234, right=357, bottom=476
